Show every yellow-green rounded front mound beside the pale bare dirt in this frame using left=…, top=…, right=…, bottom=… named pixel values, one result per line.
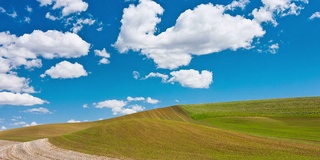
left=50, top=119, right=320, bottom=160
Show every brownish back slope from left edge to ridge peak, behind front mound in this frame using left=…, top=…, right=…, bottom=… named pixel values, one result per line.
left=0, top=107, right=192, bottom=142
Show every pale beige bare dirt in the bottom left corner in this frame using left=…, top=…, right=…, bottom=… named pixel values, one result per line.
left=0, top=139, right=116, bottom=160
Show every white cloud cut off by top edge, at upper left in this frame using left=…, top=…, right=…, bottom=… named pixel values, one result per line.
left=37, top=0, right=88, bottom=16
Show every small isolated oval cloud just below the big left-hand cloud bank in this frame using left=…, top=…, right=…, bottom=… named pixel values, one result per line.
left=41, top=61, right=88, bottom=79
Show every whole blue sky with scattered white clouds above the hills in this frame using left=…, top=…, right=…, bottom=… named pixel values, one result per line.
left=0, top=0, right=320, bottom=130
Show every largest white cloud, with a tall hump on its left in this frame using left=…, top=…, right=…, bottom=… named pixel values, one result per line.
left=114, top=0, right=265, bottom=69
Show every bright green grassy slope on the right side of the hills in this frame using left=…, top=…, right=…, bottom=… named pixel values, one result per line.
left=183, top=97, right=320, bottom=145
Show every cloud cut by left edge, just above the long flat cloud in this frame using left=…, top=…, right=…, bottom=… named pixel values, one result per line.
left=0, top=73, right=35, bottom=93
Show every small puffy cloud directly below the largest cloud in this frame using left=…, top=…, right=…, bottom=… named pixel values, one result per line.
left=168, top=69, right=213, bottom=88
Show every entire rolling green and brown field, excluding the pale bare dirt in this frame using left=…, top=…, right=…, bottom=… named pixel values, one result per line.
left=0, top=97, right=320, bottom=160
